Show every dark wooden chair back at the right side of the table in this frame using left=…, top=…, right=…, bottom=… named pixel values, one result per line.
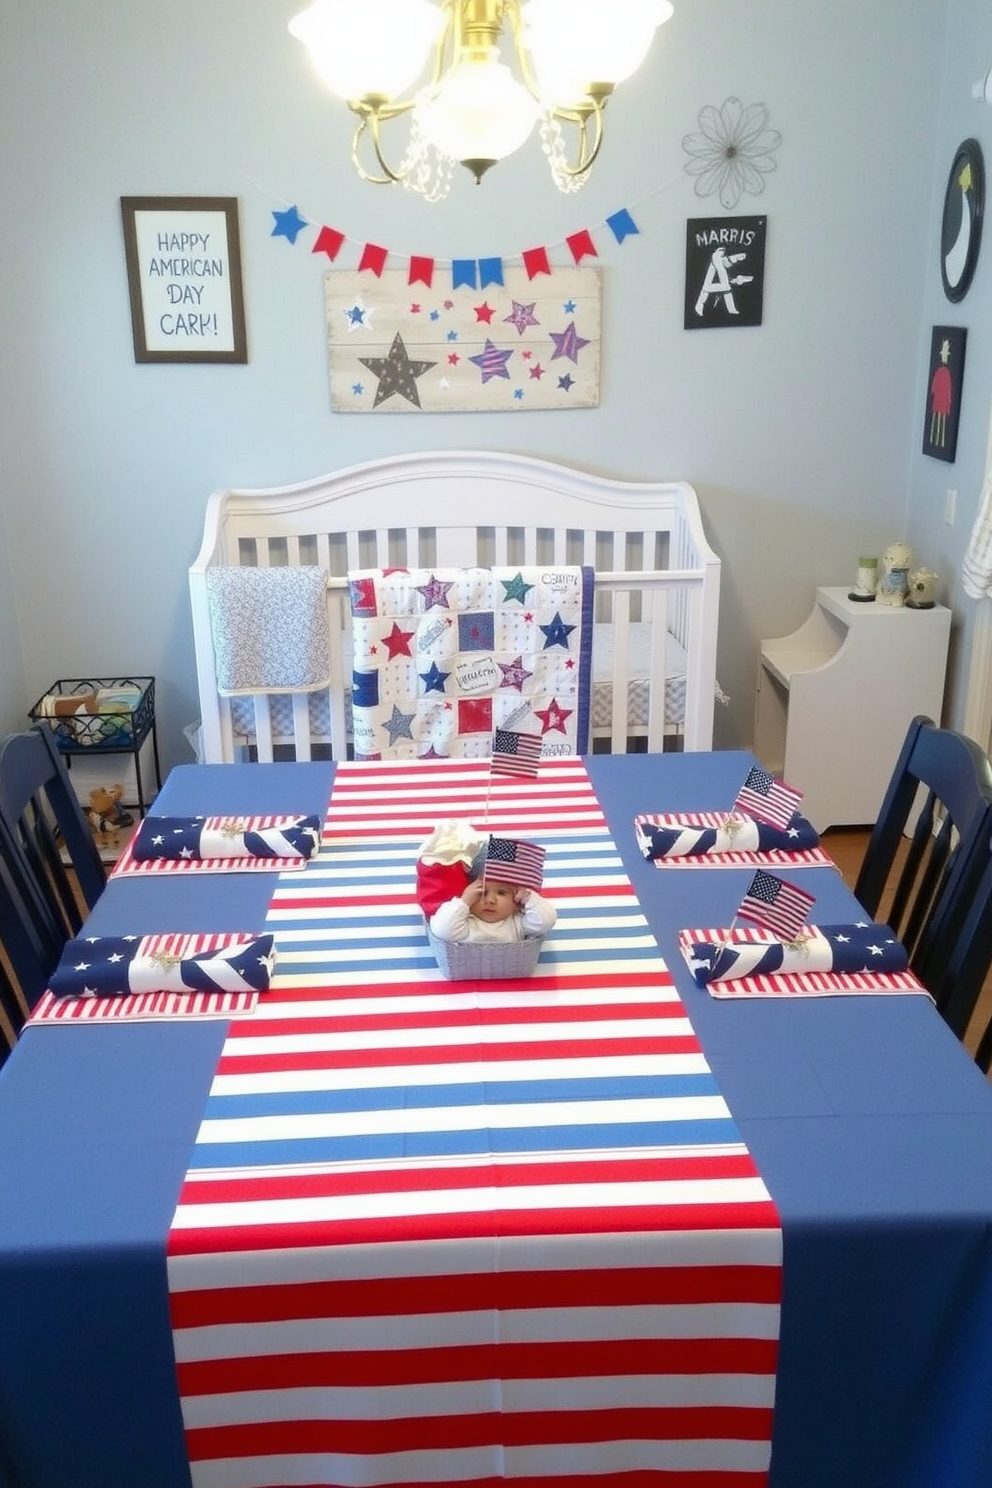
left=854, top=717, right=992, bottom=1007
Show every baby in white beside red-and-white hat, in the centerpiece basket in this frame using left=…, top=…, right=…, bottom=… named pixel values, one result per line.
left=416, top=821, right=556, bottom=943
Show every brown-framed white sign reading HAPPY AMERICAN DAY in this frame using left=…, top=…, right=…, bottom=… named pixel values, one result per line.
left=120, top=196, right=248, bottom=362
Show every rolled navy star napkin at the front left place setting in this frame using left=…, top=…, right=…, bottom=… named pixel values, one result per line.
left=48, top=934, right=275, bottom=997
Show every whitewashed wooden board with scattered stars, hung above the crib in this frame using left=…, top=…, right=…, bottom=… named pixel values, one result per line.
left=324, top=267, right=601, bottom=414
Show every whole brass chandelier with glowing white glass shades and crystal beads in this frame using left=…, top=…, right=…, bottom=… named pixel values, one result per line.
left=290, top=0, right=672, bottom=201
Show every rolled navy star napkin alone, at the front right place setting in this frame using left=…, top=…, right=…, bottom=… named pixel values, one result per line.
left=683, top=923, right=909, bottom=987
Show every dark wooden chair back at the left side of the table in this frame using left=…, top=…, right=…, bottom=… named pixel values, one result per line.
left=0, top=723, right=107, bottom=975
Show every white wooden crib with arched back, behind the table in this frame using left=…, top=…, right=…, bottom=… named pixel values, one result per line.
left=189, top=451, right=720, bottom=763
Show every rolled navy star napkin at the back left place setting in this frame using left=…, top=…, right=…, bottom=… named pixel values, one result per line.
left=131, top=817, right=320, bottom=863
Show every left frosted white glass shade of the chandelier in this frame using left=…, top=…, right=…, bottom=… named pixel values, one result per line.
left=289, top=0, right=445, bottom=101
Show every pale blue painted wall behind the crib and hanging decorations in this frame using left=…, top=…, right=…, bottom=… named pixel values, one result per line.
left=0, top=0, right=963, bottom=762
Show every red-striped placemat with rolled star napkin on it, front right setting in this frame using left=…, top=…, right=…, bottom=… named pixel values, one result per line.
left=678, top=921, right=930, bottom=997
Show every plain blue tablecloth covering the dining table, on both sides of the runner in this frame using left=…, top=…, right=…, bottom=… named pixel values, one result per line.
left=0, top=750, right=992, bottom=1488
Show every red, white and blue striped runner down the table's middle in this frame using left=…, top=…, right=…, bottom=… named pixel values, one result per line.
left=168, top=760, right=781, bottom=1488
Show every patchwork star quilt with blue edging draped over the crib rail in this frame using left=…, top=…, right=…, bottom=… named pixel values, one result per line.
left=348, top=565, right=593, bottom=759
